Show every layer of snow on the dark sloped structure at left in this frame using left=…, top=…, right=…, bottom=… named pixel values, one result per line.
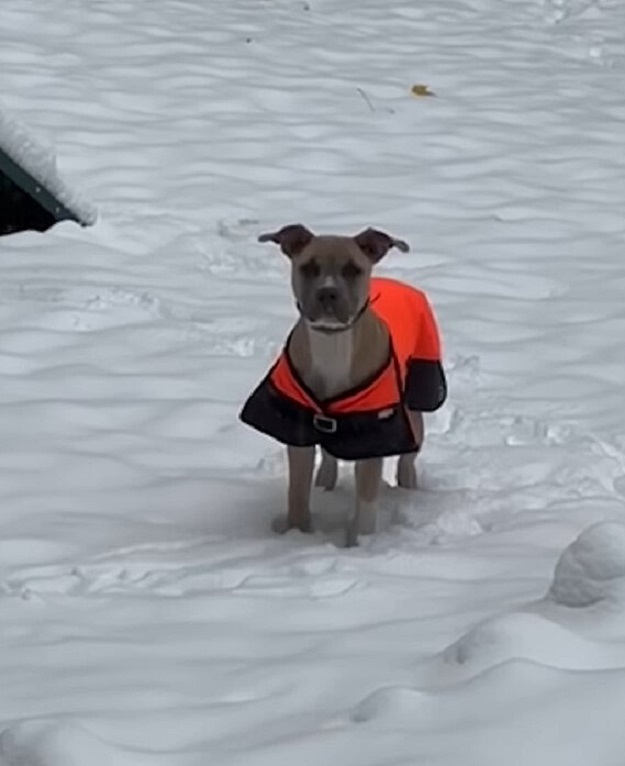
left=0, top=99, right=97, bottom=225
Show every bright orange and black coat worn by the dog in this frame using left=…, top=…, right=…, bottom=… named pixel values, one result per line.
left=240, top=277, right=447, bottom=460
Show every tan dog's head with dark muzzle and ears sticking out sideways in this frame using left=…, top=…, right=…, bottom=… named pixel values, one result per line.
left=258, top=224, right=409, bottom=332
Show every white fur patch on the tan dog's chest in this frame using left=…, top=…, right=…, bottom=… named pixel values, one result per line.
left=306, top=330, right=353, bottom=399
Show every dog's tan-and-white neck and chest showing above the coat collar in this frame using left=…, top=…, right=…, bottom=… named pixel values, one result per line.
left=288, top=308, right=390, bottom=400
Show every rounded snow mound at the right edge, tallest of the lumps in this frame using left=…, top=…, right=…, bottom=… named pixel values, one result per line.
left=547, top=522, right=625, bottom=608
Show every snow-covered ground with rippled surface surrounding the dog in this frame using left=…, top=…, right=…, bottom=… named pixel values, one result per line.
left=0, top=0, right=625, bottom=766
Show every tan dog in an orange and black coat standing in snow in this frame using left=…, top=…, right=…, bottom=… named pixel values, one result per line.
left=239, top=224, right=447, bottom=547
